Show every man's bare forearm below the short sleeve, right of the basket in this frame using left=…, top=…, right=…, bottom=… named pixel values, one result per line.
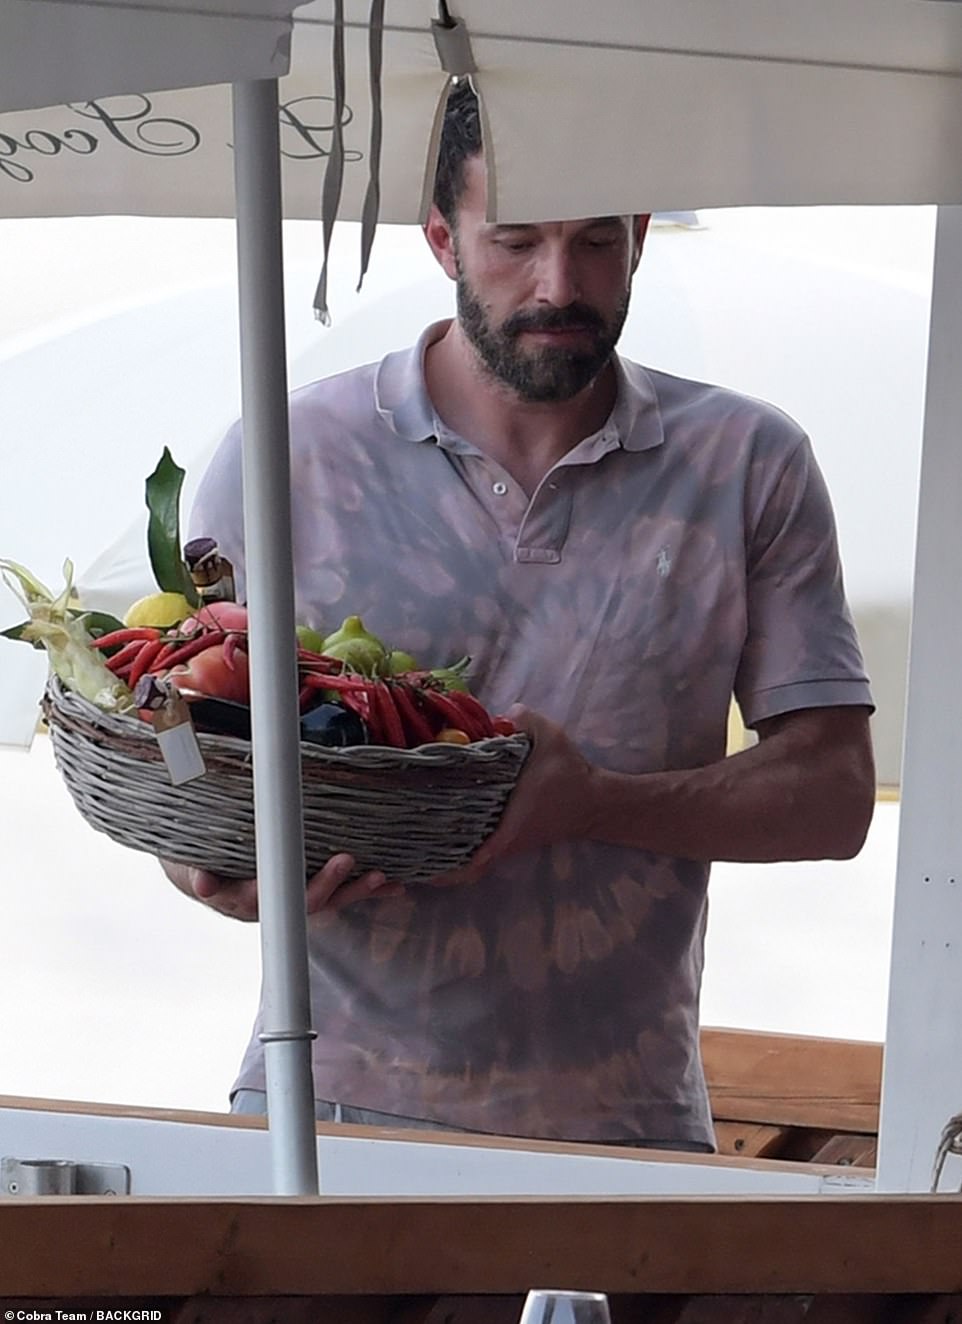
left=588, top=708, right=875, bottom=862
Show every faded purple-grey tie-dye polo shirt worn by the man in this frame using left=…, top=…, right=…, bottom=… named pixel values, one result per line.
left=191, top=323, right=872, bottom=1144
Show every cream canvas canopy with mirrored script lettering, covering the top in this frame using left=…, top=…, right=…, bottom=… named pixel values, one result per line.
left=0, top=0, right=962, bottom=230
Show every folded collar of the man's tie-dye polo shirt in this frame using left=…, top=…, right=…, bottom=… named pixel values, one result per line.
left=374, top=319, right=664, bottom=451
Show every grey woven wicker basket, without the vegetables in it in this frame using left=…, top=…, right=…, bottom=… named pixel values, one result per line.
left=44, top=678, right=528, bottom=883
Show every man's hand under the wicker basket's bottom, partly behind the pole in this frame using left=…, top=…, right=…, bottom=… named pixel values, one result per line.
left=160, top=854, right=404, bottom=922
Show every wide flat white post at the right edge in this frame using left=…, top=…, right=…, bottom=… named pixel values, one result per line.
left=864, top=207, right=962, bottom=1192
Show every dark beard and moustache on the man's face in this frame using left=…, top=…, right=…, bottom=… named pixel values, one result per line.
left=458, top=265, right=630, bottom=404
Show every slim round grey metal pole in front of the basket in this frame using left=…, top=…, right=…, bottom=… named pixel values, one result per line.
left=233, top=79, right=318, bottom=1196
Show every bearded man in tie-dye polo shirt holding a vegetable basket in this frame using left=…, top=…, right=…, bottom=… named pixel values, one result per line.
left=165, top=85, right=875, bottom=1151
